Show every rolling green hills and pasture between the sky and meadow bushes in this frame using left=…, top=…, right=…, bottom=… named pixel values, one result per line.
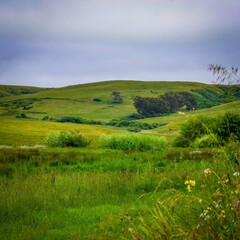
left=0, top=81, right=240, bottom=145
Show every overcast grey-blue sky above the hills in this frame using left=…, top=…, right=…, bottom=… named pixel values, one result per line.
left=0, top=0, right=240, bottom=87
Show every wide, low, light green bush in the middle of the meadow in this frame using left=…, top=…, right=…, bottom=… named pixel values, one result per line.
left=99, top=133, right=167, bottom=152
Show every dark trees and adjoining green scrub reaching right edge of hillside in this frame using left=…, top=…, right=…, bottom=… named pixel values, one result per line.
left=133, top=85, right=240, bottom=117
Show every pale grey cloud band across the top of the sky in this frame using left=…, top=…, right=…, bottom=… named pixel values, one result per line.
left=0, top=0, right=240, bottom=41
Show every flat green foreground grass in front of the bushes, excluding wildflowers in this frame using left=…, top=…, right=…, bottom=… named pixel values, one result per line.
left=0, top=148, right=238, bottom=239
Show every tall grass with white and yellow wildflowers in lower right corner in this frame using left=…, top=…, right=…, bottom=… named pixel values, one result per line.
left=130, top=145, right=240, bottom=240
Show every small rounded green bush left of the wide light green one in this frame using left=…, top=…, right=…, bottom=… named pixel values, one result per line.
left=45, top=130, right=91, bottom=147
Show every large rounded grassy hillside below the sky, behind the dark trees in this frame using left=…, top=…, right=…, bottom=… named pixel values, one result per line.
left=0, top=81, right=238, bottom=121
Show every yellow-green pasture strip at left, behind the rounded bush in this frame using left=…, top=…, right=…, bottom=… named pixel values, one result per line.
left=0, top=117, right=124, bottom=146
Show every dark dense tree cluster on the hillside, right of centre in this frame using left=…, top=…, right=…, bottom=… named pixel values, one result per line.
left=133, top=92, right=197, bottom=116
